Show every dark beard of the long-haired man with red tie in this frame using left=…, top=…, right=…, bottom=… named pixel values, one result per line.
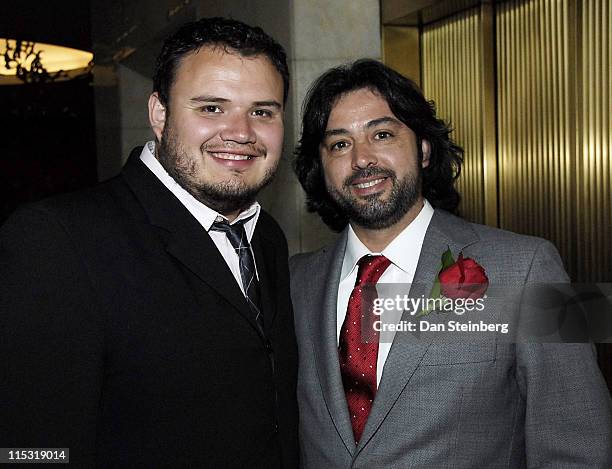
left=327, top=165, right=423, bottom=230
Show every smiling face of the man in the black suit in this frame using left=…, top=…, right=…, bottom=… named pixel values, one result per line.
left=149, top=46, right=283, bottom=218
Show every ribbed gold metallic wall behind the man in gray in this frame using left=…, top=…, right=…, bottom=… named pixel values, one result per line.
left=404, top=0, right=612, bottom=281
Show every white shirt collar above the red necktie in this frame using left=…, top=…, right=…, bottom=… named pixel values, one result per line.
left=340, top=199, right=434, bottom=281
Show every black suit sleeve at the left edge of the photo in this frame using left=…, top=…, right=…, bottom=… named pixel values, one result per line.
left=0, top=209, right=103, bottom=466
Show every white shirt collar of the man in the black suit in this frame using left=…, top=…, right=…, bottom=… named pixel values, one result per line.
left=140, top=141, right=261, bottom=242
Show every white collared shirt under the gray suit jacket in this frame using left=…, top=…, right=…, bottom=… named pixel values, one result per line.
left=336, top=200, right=434, bottom=385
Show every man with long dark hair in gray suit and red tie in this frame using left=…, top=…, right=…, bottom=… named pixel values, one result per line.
left=290, top=60, right=612, bottom=469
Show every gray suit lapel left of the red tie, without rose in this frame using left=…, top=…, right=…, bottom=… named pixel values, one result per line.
left=310, top=230, right=355, bottom=454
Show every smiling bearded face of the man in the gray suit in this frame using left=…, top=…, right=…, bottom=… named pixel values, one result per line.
left=319, top=89, right=430, bottom=229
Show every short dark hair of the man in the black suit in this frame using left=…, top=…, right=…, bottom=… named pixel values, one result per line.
left=153, top=17, right=289, bottom=106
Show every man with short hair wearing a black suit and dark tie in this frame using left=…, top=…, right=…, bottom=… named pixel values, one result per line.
left=0, top=18, right=297, bottom=468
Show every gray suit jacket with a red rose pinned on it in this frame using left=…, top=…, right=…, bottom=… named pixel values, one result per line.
left=290, top=210, right=612, bottom=469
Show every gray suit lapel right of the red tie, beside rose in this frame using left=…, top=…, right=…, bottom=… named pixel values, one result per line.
left=357, top=210, right=477, bottom=452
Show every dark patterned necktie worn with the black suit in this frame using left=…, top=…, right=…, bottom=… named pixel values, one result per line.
left=211, top=218, right=263, bottom=330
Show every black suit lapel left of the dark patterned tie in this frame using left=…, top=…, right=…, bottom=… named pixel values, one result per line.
left=122, top=148, right=259, bottom=332
